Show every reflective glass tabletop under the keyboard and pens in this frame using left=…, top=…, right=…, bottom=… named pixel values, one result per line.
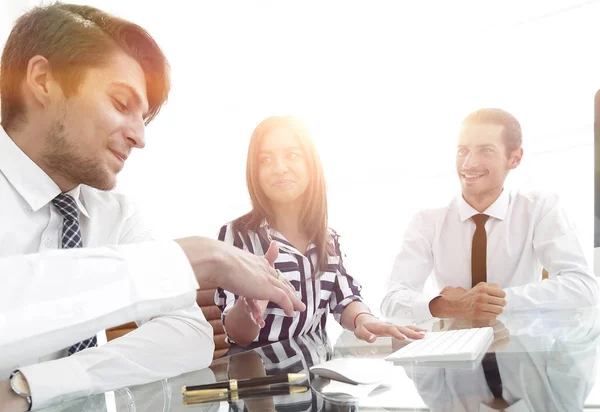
left=39, top=308, right=600, bottom=412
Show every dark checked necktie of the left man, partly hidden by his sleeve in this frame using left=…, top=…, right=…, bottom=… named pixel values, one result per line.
left=52, top=193, right=98, bottom=356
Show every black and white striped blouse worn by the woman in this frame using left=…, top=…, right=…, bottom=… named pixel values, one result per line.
left=215, top=221, right=362, bottom=343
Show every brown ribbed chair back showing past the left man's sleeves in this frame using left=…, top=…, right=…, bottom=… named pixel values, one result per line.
left=106, top=282, right=229, bottom=359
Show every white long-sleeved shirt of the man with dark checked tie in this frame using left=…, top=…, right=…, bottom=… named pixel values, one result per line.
left=0, top=128, right=214, bottom=409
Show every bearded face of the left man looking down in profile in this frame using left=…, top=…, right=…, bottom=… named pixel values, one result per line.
left=42, top=52, right=148, bottom=190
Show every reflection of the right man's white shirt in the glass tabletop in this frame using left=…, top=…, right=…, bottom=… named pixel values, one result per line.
left=404, top=308, right=600, bottom=412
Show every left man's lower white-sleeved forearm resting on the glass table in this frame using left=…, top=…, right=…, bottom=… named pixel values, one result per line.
left=20, top=305, right=214, bottom=407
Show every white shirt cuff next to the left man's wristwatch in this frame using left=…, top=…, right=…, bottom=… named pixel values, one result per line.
left=19, top=357, right=92, bottom=410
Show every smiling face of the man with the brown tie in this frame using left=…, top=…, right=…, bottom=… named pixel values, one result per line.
left=456, top=124, right=520, bottom=197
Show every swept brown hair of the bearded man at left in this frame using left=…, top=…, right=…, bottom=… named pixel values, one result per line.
left=0, top=2, right=171, bottom=128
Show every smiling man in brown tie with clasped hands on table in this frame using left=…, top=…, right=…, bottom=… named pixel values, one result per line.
left=381, top=109, right=599, bottom=320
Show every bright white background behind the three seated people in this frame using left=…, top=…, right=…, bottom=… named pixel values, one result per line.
left=0, top=0, right=600, bottom=309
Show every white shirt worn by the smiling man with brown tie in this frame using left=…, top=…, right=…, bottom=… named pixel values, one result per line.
left=381, top=190, right=599, bottom=320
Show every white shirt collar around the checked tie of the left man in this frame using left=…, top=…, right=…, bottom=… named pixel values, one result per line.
left=0, top=126, right=89, bottom=218
